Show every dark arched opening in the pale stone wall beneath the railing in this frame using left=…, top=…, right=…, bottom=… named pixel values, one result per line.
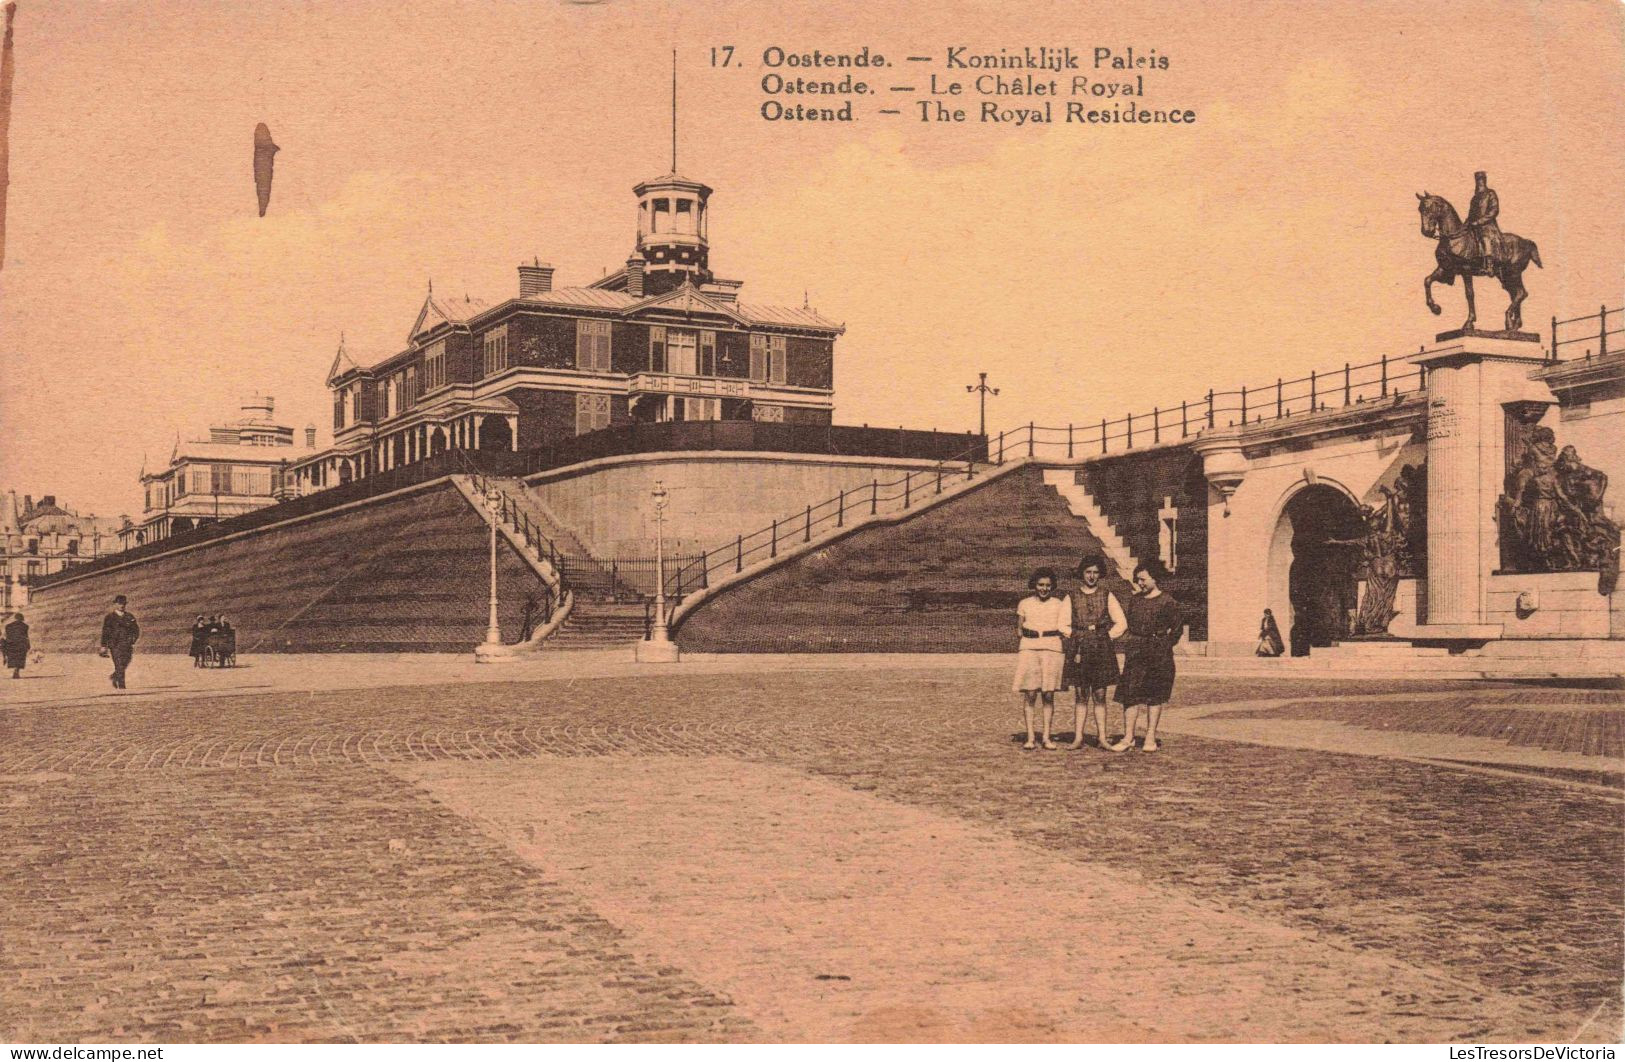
left=1269, top=482, right=1363, bottom=656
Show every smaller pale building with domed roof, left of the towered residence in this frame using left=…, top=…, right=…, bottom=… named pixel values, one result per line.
left=119, top=395, right=315, bottom=549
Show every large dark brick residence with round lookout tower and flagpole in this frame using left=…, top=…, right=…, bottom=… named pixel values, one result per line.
left=293, top=174, right=843, bottom=494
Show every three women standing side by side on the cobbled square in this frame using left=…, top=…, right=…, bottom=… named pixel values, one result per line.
left=1014, top=554, right=1185, bottom=752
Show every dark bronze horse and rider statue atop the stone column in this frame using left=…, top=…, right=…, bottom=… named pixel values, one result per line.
left=1417, top=171, right=1545, bottom=331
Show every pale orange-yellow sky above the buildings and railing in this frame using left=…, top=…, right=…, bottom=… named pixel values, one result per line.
left=0, top=0, right=1625, bottom=515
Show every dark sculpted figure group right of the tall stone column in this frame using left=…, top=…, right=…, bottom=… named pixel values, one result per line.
left=1498, top=427, right=1620, bottom=594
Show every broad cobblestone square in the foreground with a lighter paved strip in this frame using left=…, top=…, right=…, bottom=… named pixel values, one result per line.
left=0, top=669, right=1625, bottom=1041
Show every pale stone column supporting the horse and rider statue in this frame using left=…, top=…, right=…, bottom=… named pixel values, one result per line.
left=1411, top=331, right=1552, bottom=638
